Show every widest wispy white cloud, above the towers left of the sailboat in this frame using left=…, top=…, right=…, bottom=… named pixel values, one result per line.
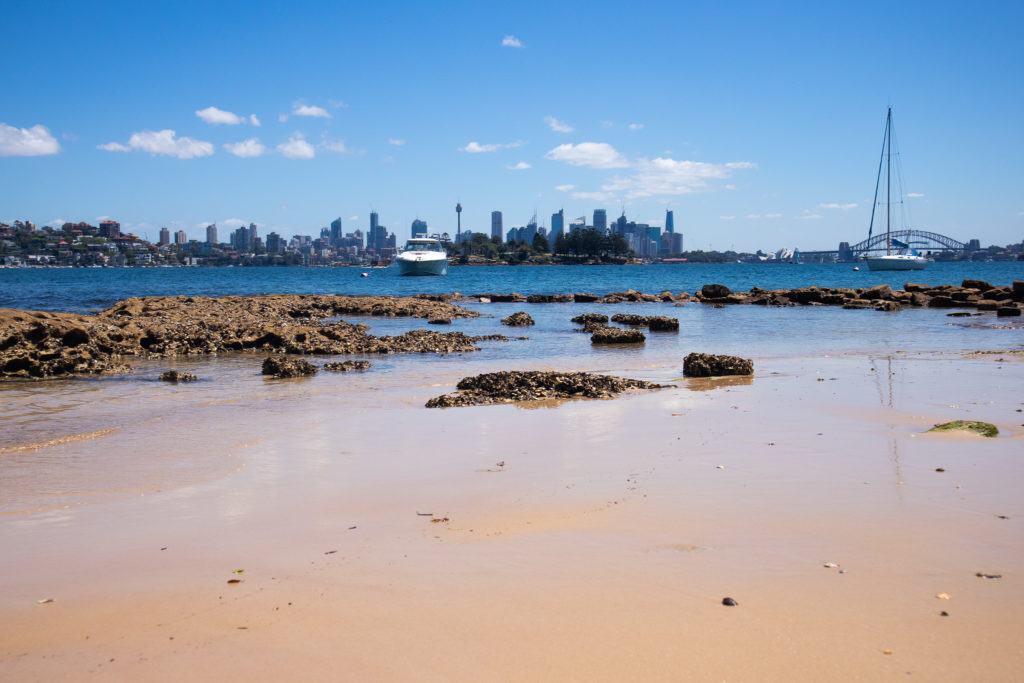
left=601, top=157, right=756, bottom=199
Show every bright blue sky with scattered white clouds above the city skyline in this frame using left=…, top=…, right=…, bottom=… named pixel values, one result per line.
left=0, top=0, right=1024, bottom=251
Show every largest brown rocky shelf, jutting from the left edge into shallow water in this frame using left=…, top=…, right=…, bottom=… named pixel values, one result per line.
left=0, top=295, right=478, bottom=379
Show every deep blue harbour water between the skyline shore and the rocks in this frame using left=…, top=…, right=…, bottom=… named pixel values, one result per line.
left=0, top=261, right=1024, bottom=312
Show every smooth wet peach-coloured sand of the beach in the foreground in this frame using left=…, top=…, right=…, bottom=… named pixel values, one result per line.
left=0, top=353, right=1024, bottom=681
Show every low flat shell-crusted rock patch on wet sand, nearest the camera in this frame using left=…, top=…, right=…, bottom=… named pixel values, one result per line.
left=426, top=371, right=663, bottom=408
